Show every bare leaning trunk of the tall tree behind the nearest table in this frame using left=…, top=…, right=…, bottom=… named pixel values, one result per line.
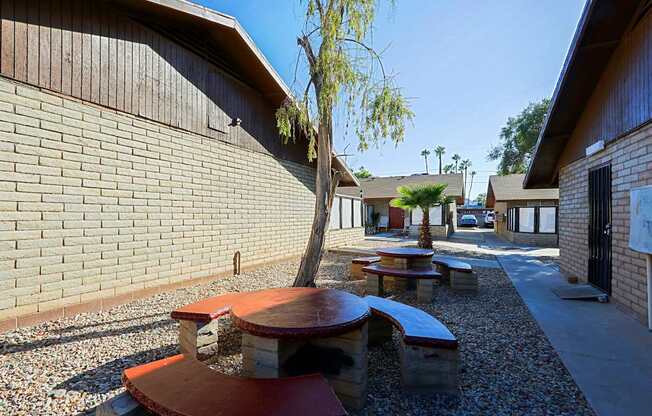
left=293, top=105, right=340, bottom=287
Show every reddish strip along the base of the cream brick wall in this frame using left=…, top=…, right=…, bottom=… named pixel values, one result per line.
left=0, top=256, right=297, bottom=334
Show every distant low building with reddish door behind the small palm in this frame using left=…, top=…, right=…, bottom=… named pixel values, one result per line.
left=338, top=174, right=464, bottom=238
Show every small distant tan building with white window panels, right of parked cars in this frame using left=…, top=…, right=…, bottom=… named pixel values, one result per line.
left=486, top=174, right=559, bottom=247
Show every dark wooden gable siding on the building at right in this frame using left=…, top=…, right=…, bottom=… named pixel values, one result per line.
left=558, top=8, right=652, bottom=168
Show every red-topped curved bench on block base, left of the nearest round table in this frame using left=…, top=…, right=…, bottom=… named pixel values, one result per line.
left=170, top=292, right=248, bottom=360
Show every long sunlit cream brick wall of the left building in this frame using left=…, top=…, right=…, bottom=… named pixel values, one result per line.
left=0, top=78, right=363, bottom=320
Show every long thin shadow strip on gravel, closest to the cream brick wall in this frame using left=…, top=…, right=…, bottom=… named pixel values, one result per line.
left=0, top=317, right=176, bottom=356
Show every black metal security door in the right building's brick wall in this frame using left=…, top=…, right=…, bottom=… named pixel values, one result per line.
left=589, top=166, right=611, bottom=294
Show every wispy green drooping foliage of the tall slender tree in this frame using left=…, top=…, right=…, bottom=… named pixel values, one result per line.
left=276, top=0, right=413, bottom=160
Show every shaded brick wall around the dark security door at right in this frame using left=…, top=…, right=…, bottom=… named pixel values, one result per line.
left=559, top=126, right=652, bottom=321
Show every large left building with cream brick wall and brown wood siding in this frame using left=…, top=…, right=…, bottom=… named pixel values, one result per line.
left=0, top=0, right=364, bottom=330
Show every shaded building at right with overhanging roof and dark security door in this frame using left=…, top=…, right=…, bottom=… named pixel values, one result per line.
left=525, top=0, right=652, bottom=321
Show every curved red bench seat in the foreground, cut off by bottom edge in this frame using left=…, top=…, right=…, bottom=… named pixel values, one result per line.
left=113, top=354, right=346, bottom=416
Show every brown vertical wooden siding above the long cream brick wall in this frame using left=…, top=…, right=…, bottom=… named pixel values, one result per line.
left=0, top=0, right=306, bottom=163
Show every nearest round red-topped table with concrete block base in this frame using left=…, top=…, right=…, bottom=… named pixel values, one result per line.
left=231, top=288, right=370, bottom=409
